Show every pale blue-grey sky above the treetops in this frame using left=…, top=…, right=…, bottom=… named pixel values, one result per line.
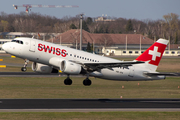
left=0, top=0, right=180, bottom=20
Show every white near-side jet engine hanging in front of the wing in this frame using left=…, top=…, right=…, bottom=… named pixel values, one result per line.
left=61, top=60, right=82, bottom=75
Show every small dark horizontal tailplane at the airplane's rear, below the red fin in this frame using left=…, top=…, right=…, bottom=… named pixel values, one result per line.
left=144, top=72, right=180, bottom=76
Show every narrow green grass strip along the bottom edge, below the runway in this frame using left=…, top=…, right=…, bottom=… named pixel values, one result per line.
left=0, top=112, right=180, bottom=120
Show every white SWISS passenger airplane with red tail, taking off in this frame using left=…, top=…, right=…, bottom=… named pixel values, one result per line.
left=2, top=37, right=172, bottom=86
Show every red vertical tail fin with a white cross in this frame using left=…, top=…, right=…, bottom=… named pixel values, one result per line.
left=136, top=39, right=169, bottom=66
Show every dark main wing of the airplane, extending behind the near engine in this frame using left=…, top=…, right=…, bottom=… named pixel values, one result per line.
left=83, top=61, right=144, bottom=71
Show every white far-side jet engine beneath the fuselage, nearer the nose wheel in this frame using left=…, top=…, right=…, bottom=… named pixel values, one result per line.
left=32, top=62, right=58, bottom=73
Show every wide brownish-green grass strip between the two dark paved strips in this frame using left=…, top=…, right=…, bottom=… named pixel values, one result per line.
left=0, top=77, right=180, bottom=98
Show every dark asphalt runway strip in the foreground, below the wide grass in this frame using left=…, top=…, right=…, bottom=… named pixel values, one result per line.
left=0, top=99, right=180, bottom=112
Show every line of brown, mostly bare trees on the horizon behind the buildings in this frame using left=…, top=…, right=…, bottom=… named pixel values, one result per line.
left=0, top=12, right=180, bottom=44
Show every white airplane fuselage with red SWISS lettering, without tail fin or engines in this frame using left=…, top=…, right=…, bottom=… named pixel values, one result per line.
left=3, top=38, right=165, bottom=81
